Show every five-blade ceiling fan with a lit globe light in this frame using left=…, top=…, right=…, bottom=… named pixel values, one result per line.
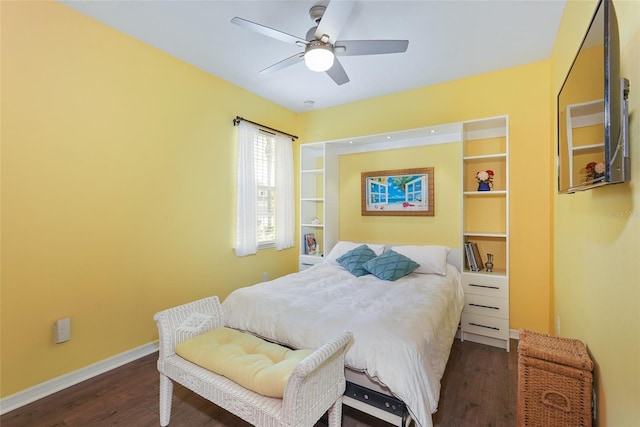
left=231, top=1, right=409, bottom=85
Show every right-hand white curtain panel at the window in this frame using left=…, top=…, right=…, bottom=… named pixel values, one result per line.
left=275, top=135, right=295, bottom=250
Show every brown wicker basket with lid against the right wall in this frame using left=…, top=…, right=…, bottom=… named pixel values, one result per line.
left=517, top=329, right=593, bottom=427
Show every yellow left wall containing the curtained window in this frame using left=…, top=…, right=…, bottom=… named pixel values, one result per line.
left=1, top=1, right=297, bottom=396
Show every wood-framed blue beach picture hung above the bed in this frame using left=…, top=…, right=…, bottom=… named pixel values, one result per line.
left=361, top=168, right=435, bottom=216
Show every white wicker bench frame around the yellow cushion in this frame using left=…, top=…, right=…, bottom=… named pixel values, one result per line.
left=154, top=297, right=352, bottom=427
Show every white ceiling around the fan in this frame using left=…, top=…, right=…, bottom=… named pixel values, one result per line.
left=61, top=0, right=566, bottom=112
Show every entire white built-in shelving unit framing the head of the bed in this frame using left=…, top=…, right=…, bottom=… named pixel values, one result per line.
left=299, top=116, right=510, bottom=351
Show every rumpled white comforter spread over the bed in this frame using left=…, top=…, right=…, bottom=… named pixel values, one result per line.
left=222, top=263, right=464, bottom=427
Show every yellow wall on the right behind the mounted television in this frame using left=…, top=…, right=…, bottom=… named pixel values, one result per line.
left=551, top=0, right=640, bottom=427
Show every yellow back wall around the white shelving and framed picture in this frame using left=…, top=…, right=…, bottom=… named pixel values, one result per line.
left=299, top=61, right=555, bottom=332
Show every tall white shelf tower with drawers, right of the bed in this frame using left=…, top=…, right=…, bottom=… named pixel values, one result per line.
left=460, top=116, right=509, bottom=351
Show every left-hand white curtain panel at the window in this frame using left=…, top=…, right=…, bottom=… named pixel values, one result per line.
left=235, top=121, right=258, bottom=256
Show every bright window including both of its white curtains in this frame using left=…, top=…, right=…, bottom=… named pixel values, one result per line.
left=235, top=121, right=295, bottom=256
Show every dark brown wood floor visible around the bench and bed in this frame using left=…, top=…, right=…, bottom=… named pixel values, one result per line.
left=0, top=340, right=518, bottom=427
